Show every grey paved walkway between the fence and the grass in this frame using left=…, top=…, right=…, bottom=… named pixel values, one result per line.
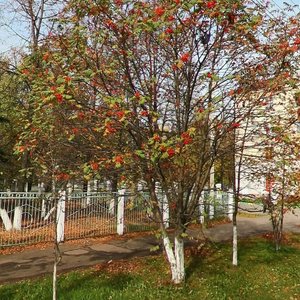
left=0, top=213, right=300, bottom=283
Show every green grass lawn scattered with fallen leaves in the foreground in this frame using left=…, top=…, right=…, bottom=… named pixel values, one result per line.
left=0, top=235, right=300, bottom=300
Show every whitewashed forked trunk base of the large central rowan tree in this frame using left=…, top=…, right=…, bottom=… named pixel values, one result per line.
left=163, top=236, right=185, bottom=284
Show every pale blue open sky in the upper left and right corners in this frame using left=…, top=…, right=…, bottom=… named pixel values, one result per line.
left=0, top=0, right=300, bottom=53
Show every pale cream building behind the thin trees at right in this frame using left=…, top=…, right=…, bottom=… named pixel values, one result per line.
left=235, top=84, right=300, bottom=196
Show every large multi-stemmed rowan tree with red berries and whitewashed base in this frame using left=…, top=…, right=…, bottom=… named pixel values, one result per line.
left=18, top=0, right=298, bottom=283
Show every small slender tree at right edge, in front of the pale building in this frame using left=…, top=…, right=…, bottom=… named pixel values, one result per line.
left=245, top=86, right=300, bottom=250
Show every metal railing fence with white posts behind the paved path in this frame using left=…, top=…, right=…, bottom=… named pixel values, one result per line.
left=0, top=189, right=233, bottom=246
